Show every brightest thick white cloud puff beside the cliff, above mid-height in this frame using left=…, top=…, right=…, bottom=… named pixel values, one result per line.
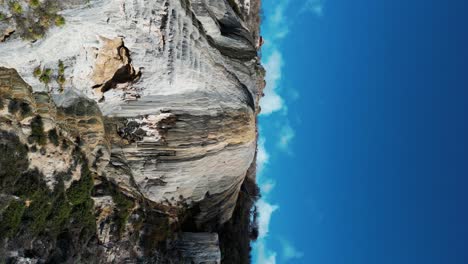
left=260, top=49, right=284, bottom=115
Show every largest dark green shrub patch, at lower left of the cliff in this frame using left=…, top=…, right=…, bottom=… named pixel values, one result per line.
left=0, top=148, right=96, bottom=240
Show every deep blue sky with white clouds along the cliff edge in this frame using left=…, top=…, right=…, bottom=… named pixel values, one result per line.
left=253, top=0, right=468, bottom=264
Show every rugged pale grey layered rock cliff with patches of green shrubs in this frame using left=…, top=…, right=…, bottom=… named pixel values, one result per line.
left=0, top=0, right=264, bottom=263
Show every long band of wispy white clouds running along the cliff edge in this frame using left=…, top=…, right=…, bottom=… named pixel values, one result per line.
left=254, top=0, right=299, bottom=264
